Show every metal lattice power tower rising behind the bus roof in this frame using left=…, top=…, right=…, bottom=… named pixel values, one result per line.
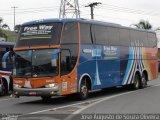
left=59, top=0, right=80, bottom=18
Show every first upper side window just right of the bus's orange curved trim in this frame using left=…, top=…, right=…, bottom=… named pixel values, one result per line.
left=80, top=23, right=92, bottom=44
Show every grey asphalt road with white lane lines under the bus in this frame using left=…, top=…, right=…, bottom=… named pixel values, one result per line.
left=0, top=76, right=160, bottom=120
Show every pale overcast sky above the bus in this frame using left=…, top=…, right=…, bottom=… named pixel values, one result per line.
left=0, top=0, right=160, bottom=29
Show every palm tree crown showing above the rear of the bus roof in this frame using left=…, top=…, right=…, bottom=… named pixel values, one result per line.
left=133, top=20, right=152, bottom=30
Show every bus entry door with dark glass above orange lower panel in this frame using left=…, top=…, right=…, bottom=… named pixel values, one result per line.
left=60, top=49, right=77, bottom=94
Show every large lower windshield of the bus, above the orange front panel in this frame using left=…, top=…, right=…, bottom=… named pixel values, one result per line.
left=13, top=49, right=58, bottom=78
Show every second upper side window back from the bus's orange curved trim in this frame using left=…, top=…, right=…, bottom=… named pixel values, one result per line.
left=94, top=25, right=109, bottom=45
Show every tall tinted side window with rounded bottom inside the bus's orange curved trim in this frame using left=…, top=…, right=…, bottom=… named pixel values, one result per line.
left=61, top=23, right=78, bottom=75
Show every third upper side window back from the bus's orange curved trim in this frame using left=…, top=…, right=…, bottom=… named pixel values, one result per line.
left=107, top=27, right=120, bottom=45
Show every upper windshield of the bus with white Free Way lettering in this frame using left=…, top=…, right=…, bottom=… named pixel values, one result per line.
left=16, top=23, right=62, bottom=47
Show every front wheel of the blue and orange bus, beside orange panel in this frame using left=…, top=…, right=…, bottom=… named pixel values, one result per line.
left=78, top=80, right=88, bottom=100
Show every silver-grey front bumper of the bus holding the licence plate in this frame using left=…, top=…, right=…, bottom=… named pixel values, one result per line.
left=14, top=86, right=60, bottom=97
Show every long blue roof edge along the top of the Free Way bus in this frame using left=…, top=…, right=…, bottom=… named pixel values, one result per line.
left=23, top=18, right=155, bottom=33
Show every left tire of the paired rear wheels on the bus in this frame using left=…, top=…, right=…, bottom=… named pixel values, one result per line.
left=131, top=74, right=141, bottom=90
